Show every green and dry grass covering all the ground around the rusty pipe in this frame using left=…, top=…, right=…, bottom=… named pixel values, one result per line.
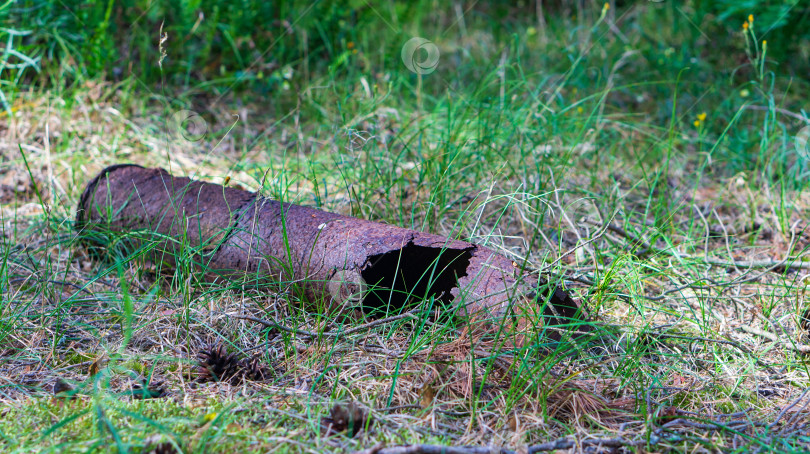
left=0, top=1, right=810, bottom=453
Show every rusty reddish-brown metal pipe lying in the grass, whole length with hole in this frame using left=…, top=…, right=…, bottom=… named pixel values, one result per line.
left=76, top=165, right=581, bottom=338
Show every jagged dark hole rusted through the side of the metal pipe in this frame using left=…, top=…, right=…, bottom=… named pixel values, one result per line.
left=360, top=244, right=472, bottom=309
